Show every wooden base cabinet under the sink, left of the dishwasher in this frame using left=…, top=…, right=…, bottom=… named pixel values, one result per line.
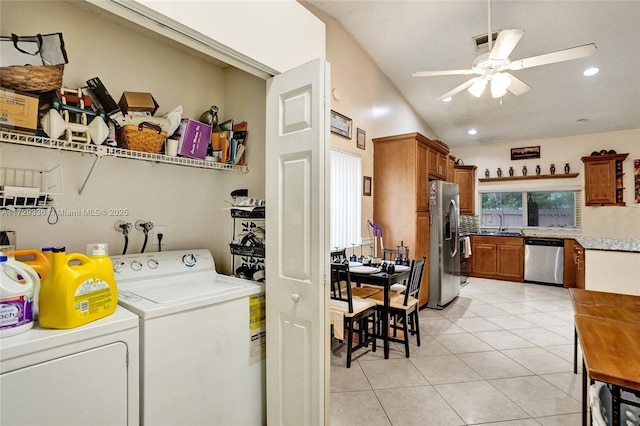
left=469, top=235, right=524, bottom=282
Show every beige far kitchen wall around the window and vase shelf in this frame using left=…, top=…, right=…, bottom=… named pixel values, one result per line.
left=451, top=129, right=640, bottom=238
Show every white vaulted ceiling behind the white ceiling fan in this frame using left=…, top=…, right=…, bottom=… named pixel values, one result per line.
left=303, top=0, right=640, bottom=147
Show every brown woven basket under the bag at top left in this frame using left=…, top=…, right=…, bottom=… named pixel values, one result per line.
left=0, top=65, right=64, bottom=92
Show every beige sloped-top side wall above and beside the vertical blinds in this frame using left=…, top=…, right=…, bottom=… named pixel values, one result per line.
left=305, top=3, right=435, bottom=243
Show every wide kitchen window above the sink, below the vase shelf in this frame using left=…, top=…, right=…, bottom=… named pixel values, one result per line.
left=480, top=190, right=582, bottom=230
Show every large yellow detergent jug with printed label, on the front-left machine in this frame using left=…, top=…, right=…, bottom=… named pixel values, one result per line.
left=39, top=247, right=118, bottom=328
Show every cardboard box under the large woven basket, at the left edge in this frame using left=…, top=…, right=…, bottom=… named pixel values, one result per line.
left=0, top=87, right=38, bottom=135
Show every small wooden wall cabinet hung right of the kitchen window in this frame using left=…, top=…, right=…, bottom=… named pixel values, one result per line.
left=581, top=154, right=629, bottom=206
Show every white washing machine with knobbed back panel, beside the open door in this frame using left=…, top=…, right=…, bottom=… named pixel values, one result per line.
left=111, top=250, right=266, bottom=426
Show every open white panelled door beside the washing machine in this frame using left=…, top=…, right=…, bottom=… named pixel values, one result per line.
left=265, top=59, right=330, bottom=426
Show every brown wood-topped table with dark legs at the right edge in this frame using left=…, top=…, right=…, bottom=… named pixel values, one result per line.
left=569, top=288, right=640, bottom=425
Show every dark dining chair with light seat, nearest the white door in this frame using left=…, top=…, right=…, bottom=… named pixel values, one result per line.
left=331, top=263, right=377, bottom=368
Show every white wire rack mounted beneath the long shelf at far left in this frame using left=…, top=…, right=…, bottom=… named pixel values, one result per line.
left=0, top=165, right=64, bottom=209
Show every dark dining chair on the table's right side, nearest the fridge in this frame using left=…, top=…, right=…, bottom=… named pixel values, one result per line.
left=367, top=257, right=427, bottom=358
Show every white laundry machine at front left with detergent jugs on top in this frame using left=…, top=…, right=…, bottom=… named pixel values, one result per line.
left=0, top=306, right=139, bottom=426
